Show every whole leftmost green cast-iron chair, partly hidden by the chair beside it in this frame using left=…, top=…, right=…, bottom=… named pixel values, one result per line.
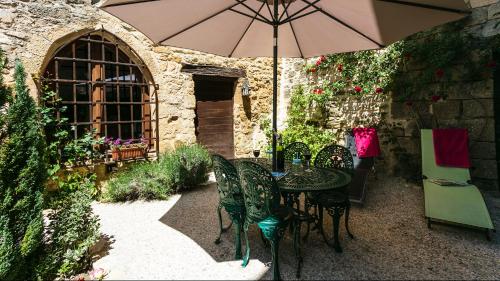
left=212, top=154, right=245, bottom=260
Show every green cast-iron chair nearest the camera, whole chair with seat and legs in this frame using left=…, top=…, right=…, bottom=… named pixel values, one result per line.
left=236, top=161, right=300, bottom=280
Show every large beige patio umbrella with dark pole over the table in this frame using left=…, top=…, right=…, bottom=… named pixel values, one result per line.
left=101, top=0, right=470, bottom=170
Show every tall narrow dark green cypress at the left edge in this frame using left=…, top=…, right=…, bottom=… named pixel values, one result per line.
left=0, top=60, right=47, bottom=279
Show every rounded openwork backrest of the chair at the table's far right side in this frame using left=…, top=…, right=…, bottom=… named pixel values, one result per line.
left=314, top=144, right=354, bottom=173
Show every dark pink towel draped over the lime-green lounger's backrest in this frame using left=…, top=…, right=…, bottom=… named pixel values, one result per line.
left=432, top=129, right=470, bottom=168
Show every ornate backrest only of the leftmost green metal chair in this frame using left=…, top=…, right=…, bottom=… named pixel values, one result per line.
left=212, top=154, right=244, bottom=206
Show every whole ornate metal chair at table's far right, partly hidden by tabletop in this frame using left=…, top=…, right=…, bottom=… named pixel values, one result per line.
left=306, top=145, right=354, bottom=252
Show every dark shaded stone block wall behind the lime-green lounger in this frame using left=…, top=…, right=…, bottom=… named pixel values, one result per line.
left=389, top=0, right=500, bottom=189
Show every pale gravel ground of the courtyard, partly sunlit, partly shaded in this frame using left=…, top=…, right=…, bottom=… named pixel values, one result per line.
left=95, top=175, right=500, bottom=280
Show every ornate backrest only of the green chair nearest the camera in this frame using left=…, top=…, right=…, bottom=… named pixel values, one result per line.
left=236, top=161, right=281, bottom=229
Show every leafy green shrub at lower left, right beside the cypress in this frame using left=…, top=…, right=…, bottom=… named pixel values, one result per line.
left=36, top=189, right=100, bottom=280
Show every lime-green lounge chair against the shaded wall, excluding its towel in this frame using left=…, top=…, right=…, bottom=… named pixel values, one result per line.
left=421, top=130, right=494, bottom=237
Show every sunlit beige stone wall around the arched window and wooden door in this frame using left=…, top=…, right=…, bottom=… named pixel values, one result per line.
left=0, top=0, right=290, bottom=156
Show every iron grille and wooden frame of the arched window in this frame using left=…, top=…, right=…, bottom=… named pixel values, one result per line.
left=40, top=29, right=159, bottom=159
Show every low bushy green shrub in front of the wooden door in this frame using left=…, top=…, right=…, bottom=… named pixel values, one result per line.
left=103, top=145, right=211, bottom=202
